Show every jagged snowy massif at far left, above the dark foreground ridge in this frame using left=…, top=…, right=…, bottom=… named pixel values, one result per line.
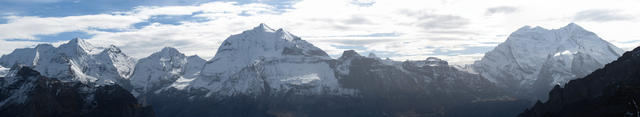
left=0, top=38, right=135, bottom=87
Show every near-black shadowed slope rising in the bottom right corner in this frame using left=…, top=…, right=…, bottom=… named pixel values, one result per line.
left=519, top=47, right=640, bottom=117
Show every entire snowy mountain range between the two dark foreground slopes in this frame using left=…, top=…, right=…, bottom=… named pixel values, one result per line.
left=0, top=23, right=622, bottom=117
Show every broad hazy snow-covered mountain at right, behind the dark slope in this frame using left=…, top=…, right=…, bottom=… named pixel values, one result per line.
left=474, top=23, right=623, bottom=97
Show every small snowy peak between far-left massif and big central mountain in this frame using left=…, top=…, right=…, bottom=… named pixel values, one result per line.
left=130, top=47, right=205, bottom=96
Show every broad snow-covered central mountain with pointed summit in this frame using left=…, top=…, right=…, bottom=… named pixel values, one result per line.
left=172, top=24, right=338, bottom=95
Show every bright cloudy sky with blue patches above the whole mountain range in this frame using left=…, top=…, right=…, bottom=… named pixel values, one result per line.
left=0, top=0, right=640, bottom=64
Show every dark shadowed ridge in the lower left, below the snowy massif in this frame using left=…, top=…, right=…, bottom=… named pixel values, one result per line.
left=0, top=67, right=155, bottom=117
